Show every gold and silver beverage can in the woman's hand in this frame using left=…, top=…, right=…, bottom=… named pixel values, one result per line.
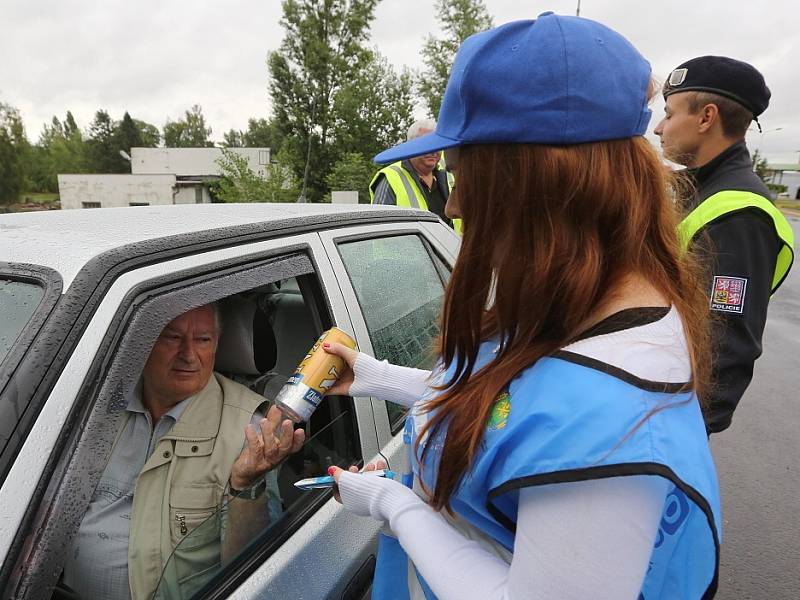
left=275, top=327, right=356, bottom=423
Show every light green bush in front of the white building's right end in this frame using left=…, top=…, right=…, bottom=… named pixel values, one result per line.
left=213, top=148, right=298, bottom=202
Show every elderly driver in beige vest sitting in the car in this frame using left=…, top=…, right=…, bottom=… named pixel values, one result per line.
left=64, top=305, right=305, bottom=599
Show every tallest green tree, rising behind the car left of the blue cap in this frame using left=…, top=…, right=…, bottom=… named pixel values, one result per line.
left=268, top=0, right=378, bottom=201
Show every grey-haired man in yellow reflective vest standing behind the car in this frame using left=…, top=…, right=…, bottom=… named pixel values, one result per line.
left=369, top=119, right=461, bottom=231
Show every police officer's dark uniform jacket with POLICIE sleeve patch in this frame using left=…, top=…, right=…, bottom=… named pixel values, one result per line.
left=687, top=141, right=781, bottom=433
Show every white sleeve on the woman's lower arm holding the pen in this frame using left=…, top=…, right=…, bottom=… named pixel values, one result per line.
left=339, top=473, right=670, bottom=600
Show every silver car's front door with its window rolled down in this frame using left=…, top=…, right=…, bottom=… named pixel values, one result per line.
left=0, top=233, right=378, bottom=598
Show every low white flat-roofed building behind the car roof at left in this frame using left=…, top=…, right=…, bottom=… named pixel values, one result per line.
left=58, top=148, right=270, bottom=208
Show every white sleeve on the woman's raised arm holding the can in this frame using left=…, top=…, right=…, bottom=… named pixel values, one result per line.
left=350, top=352, right=431, bottom=408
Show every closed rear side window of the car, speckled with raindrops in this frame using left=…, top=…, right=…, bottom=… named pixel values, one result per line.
left=338, top=235, right=448, bottom=431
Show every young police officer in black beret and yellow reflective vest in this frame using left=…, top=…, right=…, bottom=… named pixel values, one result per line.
left=655, top=56, right=794, bottom=433
